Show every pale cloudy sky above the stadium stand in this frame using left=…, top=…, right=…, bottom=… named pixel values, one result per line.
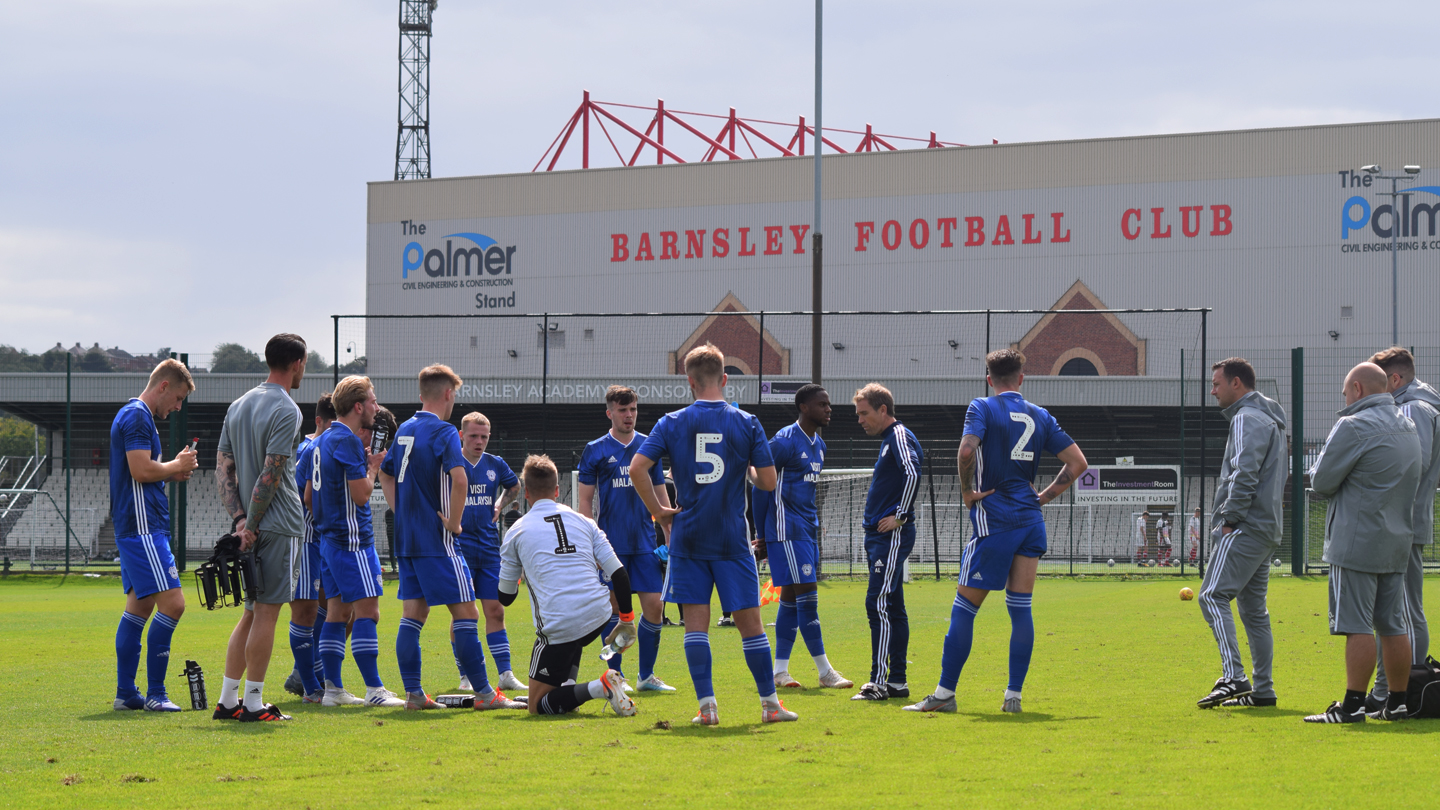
left=0, top=0, right=1440, bottom=362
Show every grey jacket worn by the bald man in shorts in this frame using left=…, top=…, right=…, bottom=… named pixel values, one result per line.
left=1310, top=393, right=1421, bottom=574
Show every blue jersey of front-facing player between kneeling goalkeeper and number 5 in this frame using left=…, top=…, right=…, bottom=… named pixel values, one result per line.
left=577, top=431, right=665, bottom=555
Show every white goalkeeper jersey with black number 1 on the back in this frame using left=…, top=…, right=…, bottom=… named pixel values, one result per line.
left=500, top=500, right=621, bottom=644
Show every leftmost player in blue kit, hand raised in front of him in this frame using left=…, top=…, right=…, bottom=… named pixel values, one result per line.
left=109, top=360, right=199, bottom=712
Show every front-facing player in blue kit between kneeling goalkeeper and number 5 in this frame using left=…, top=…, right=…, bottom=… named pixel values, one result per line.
left=576, top=385, right=675, bottom=692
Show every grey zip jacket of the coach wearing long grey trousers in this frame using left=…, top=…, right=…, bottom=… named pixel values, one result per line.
left=1210, top=391, right=1287, bottom=545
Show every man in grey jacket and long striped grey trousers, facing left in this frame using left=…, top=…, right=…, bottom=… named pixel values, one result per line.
left=1200, top=357, right=1287, bottom=708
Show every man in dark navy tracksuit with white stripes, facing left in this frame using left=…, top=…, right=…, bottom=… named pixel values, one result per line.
left=851, top=382, right=924, bottom=700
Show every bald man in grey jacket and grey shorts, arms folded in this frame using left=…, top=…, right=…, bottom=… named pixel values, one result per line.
left=1310, top=363, right=1421, bottom=712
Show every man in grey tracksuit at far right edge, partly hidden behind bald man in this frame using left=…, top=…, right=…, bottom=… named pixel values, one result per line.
left=1369, top=346, right=1440, bottom=708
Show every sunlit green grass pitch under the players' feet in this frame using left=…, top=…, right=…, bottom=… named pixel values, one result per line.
left=0, top=577, right=1440, bottom=810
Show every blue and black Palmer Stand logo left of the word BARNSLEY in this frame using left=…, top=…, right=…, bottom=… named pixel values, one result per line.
left=400, top=219, right=516, bottom=310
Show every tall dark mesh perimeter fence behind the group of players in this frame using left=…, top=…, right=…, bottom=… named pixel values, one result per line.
left=0, top=303, right=1440, bottom=575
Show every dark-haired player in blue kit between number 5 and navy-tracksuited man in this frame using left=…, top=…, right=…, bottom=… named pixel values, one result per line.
left=753, top=383, right=854, bottom=689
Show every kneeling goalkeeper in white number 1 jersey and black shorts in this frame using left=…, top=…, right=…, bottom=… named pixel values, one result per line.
left=500, top=455, right=636, bottom=716
